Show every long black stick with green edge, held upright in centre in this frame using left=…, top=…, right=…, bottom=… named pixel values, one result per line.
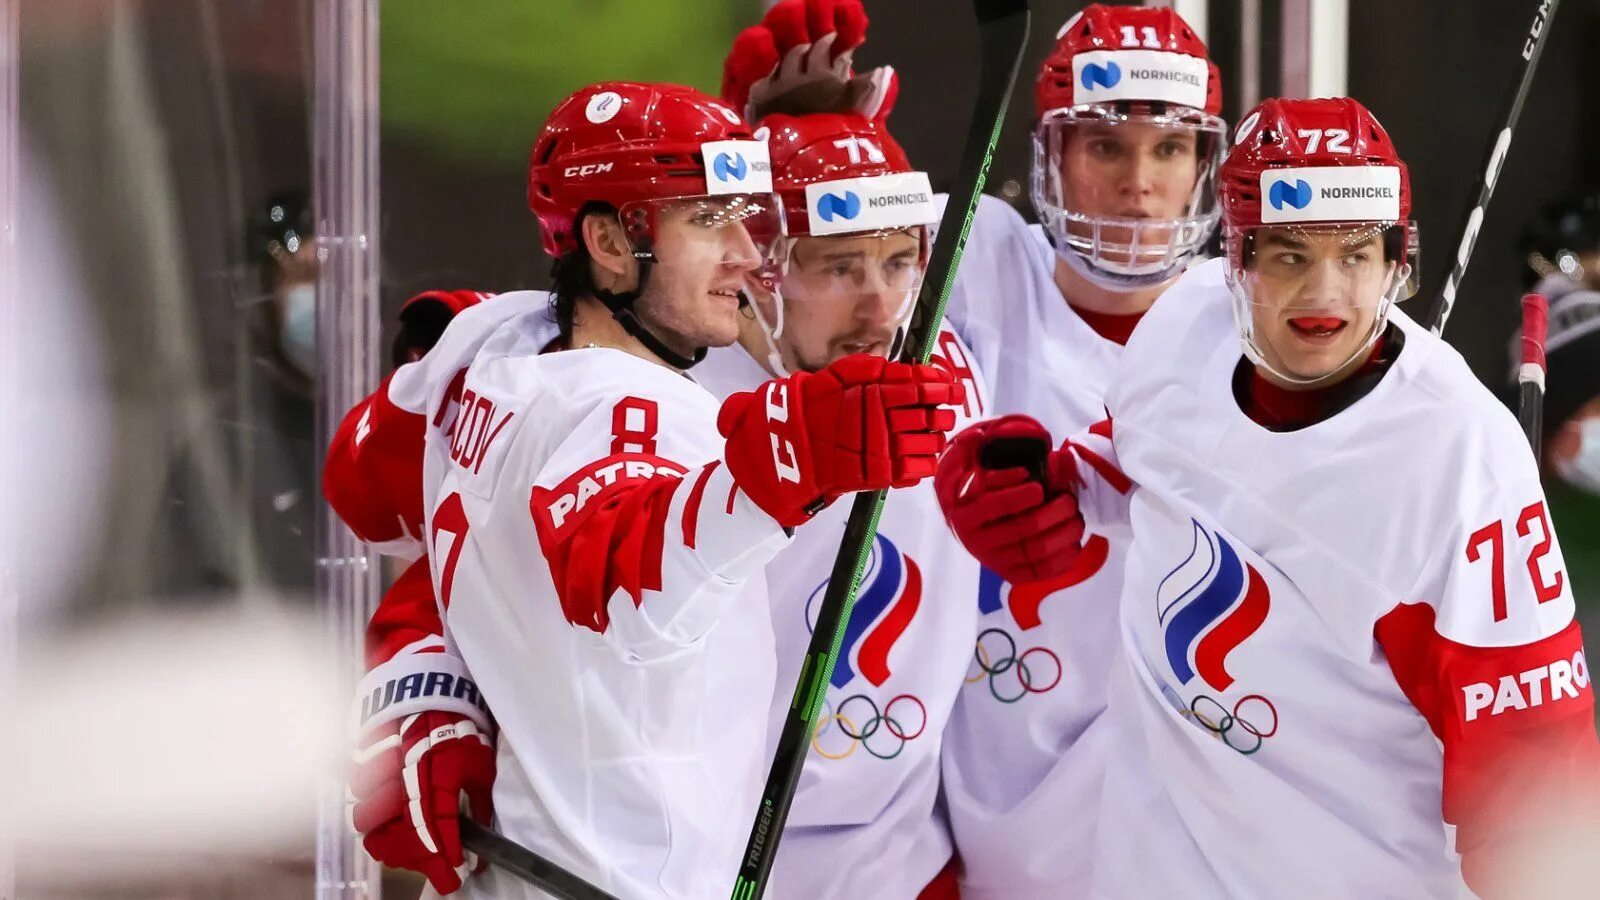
left=733, top=0, right=1029, bottom=900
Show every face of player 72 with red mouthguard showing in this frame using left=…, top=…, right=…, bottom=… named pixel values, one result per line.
left=1251, top=227, right=1398, bottom=381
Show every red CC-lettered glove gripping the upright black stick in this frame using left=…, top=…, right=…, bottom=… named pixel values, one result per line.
left=717, top=354, right=966, bottom=528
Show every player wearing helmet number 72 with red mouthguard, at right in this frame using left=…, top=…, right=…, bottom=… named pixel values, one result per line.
left=939, top=99, right=1600, bottom=900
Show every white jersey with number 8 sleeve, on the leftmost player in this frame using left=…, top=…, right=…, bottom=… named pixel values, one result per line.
left=412, top=304, right=789, bottom=900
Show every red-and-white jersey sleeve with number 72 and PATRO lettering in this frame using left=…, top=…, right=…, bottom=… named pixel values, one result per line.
left=1374, top=441, right=1600, bottom=900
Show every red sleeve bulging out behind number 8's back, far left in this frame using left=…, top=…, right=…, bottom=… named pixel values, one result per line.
left=322, top=364, right=427, bottom=559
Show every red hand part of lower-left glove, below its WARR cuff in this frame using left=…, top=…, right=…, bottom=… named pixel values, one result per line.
left=350, top=711, right=494, bottom=894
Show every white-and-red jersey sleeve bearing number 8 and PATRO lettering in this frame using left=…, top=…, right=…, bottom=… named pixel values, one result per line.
left=530, top=381, right=789, bottom=663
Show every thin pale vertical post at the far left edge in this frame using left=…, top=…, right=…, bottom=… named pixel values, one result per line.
left=0, top=0, right=22, bottom=900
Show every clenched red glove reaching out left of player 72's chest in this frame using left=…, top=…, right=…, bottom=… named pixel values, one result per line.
left=933, top=415, right=1083, bottom=585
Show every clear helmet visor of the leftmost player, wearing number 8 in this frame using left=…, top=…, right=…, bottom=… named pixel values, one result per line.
left=618, top=194, right=787, bottom=282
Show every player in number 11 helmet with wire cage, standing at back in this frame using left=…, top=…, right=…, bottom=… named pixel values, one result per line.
left=921, top=5, right=1226, bottom=900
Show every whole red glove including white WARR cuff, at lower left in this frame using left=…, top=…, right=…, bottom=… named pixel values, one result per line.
left=349, top=653, right=494, bottom=894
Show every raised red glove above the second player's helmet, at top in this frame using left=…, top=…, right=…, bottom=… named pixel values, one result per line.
left=722, top=0, right=899, bottom=122
